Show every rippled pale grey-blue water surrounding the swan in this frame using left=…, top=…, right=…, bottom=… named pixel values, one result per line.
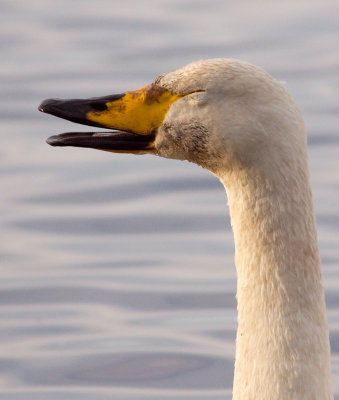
left=0, top=0, right=339, bottom=400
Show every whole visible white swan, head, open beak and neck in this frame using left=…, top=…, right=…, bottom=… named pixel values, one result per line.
left=39, top=58, right=333, bottom=400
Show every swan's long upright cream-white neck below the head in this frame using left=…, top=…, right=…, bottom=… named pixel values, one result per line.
left=222, top=149, right=333, bottom=400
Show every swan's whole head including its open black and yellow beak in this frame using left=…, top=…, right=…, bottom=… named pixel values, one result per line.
left=39, top=59, right=305, bottom=176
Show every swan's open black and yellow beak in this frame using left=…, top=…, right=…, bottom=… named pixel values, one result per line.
left=39, top=84, right=182, bottom=153
